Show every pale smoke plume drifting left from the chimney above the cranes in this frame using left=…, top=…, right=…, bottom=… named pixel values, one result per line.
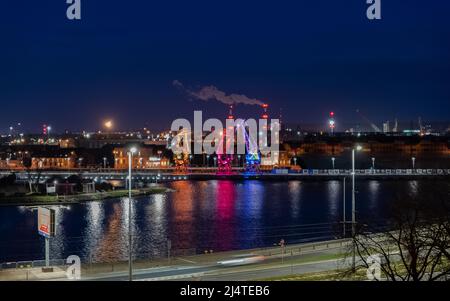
left=172, top=80, right=264, bottom=105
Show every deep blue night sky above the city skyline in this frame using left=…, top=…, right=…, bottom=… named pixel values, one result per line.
left=0, top=0, right=450, bottom=132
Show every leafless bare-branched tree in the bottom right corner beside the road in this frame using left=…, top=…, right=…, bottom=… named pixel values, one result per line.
left=351, top=182, right=450, bottom=281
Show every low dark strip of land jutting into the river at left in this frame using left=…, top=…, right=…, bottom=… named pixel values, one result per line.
left=0, top=186, right=171, bottom=206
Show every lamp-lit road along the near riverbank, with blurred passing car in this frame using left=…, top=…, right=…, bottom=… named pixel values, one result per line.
left=0, top=240, right=370, bottom=281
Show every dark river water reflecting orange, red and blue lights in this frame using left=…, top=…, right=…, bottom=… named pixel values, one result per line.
left=0, top=180, right=420, bottom=263
